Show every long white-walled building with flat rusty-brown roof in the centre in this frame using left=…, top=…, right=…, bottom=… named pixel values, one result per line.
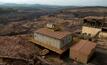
left=31, top=28, right=72, bottom=54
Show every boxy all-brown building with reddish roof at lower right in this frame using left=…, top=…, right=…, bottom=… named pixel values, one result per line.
left=70, top=40, right=96, bottom=63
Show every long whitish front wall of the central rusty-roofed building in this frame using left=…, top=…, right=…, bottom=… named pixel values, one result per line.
left=34, top=33, right=62, bottom=48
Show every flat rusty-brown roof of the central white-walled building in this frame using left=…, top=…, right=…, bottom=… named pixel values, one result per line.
left=36, top=28, right=71, bottom=39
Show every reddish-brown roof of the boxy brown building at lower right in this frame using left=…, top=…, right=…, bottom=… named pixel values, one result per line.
left=71, top=40, right=96, bottom=55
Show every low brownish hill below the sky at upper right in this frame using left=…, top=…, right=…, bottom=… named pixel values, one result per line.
left=62, top=6, right=107, bottom=17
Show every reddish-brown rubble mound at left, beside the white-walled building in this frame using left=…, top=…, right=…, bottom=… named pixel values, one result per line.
left=0, top=36, right=40, bottom=63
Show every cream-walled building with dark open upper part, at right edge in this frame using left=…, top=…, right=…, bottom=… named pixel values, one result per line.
left=82, top=17, right=107, bottom=38
